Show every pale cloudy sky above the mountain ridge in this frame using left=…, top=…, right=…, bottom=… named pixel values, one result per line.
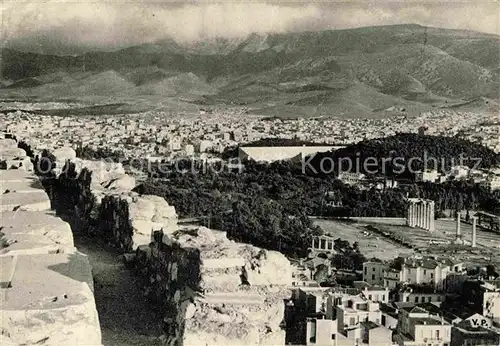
left=0, top=0, right=500, bottom=53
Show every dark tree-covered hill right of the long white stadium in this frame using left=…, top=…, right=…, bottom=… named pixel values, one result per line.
left=308, top=133, right=500, bottom=178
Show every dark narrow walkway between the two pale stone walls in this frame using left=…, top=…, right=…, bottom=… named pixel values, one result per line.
left=75, top=233, right=163, bottom=346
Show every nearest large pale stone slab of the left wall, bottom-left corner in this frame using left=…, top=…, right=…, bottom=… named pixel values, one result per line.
left=0, top=253, right=101, bottom=346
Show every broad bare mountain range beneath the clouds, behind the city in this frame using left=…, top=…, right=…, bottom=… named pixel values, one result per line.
left=0, top=25, right=500, bottom=117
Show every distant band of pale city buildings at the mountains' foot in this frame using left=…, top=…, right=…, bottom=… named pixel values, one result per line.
left=2, top=104, right=500, bottom=160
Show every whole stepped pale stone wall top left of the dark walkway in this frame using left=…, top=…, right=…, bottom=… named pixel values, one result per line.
left=0, top=139, right=101, bottom=346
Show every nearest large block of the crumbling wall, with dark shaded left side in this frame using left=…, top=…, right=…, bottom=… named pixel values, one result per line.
left=136, top=227, right=292, bottom=345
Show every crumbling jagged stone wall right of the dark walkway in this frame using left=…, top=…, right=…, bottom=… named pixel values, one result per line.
left=25, top=143, right=292, bottom=346
